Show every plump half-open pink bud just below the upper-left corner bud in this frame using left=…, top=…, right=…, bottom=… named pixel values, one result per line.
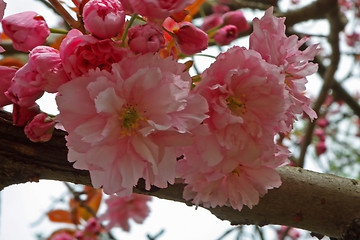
left=14, top=46, right=69, bottom=93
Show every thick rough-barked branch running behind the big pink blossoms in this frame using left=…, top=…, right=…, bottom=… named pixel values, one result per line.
left=0, top=111, right=360, bottom=239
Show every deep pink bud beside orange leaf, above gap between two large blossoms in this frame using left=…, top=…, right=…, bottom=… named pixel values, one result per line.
left=174, top=22, right=208, bottom=55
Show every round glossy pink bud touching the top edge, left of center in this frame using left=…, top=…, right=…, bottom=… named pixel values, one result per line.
left=83, top=0, right=125, bottom=39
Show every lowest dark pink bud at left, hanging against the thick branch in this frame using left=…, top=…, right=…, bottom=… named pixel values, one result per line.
left=24, top=113, right=55, bottom=142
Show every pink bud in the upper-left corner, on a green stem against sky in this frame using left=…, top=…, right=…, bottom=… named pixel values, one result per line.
left=1, top=11, right=50, bottom=52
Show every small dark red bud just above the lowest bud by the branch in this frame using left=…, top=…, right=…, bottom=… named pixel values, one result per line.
left=12, top=103, right=40, bottom=127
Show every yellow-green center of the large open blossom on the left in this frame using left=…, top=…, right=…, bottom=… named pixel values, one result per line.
left=119, top=106, right=145, bottom=136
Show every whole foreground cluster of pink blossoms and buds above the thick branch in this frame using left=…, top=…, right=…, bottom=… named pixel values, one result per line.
left=0, top=0, right=318, bottom=214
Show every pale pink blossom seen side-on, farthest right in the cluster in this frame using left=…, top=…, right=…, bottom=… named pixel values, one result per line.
left=250, top=8, right=319, bottom=131
